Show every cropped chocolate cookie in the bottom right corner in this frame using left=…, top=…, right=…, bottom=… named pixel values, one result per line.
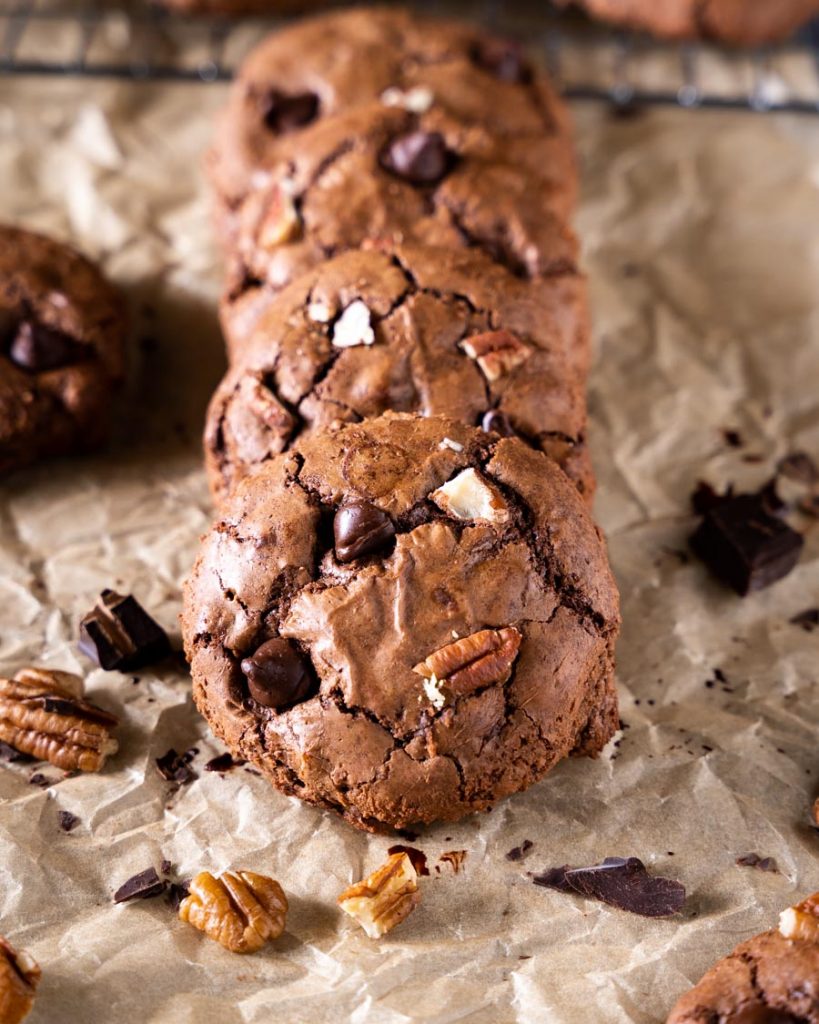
left=667, top=930, right=819, bottom=1024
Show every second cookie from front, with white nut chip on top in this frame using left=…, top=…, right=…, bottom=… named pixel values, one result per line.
left=205, top=246, right=594, bottom=500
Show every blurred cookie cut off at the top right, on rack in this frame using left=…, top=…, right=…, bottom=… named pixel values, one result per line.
left=556, top=0, right=819, bottom=46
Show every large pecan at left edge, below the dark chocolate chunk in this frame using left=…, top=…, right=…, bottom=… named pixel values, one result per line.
left=0, top=669, right=119, bottom=771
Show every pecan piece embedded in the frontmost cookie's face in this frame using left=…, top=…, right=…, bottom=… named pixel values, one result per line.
left=413, top=626, right=522, bottom=696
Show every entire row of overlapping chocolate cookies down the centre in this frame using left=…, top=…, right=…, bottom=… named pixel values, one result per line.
left=183, top=9, right=618, bottom=829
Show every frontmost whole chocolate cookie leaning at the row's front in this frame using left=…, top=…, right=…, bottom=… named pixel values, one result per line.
left=183, top=414, right=618, bottom=829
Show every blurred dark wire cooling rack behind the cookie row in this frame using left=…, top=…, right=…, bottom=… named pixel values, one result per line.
left=0, top=0, right=819, bottom=114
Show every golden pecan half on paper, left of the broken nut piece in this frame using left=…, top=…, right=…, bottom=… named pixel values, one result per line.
left=179, top=871, right=288, bottom=953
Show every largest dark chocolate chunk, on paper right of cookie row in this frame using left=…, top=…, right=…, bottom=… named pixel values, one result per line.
left=691, top=495, right=805, bottom=596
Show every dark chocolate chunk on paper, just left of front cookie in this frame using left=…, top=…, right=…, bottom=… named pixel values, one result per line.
left=80, top=590, right=171, bottom=672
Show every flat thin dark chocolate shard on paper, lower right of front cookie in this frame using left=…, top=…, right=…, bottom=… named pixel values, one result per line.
left=532, top=857, right=685, bottom=918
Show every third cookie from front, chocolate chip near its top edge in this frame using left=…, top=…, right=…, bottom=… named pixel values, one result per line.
left=224, top=100, right=577, bottom=297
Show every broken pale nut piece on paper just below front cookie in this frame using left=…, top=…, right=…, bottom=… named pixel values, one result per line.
left=338, top=853, right=421, bottom=939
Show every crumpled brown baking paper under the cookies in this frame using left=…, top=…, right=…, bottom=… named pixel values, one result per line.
left=0, top=24, right=819, bottom=1024
